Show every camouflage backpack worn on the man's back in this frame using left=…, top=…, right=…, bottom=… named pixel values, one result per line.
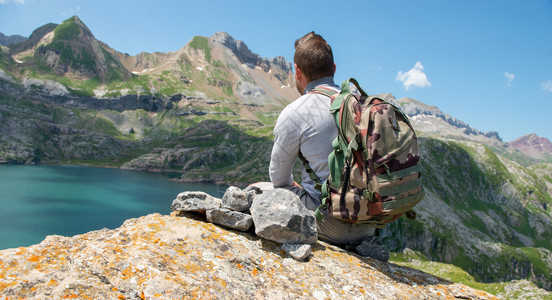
left=300, top=78, right=425, bottom=228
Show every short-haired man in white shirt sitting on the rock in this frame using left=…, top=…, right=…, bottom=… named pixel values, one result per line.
left=269, top=31, right=389, bottom=261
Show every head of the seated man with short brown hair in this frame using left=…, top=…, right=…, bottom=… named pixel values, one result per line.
left=293, top=31, right=335, bottom=94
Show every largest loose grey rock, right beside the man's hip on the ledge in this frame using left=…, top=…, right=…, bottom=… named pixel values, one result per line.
left=250, top=189, right=318, bottom=244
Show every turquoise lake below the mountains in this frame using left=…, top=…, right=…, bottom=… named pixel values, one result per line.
left=0, top=165, right=227, bottom=249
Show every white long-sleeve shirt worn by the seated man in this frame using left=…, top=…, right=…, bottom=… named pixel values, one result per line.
left=269, top=77, right=339, bottom=199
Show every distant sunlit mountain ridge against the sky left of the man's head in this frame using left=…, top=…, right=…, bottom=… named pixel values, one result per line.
left=3, top=16, right=298, bottom=106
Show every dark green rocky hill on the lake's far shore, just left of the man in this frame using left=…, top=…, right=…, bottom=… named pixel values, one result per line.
left=121, top=120, right=272, bottom=186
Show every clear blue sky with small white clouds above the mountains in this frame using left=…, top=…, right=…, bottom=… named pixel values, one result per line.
left=0, top=0, right=552, bottom=141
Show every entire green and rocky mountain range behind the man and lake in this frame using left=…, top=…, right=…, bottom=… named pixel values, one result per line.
left=0, top=17, right=552, bottom=296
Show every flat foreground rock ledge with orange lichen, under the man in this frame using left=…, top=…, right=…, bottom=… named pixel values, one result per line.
left=0, top=213, right=498, bottom=299
